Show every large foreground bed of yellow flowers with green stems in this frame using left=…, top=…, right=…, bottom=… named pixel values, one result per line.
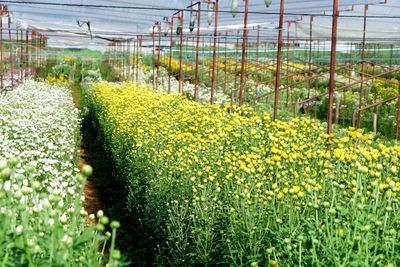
left=88, top=83, right=400, bottom=266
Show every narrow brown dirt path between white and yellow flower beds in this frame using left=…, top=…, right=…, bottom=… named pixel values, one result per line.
left=72, top=88, right=106, bottom=222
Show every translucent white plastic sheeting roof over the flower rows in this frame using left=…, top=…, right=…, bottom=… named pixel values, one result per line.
left=0, top=0, right=400, bottom=48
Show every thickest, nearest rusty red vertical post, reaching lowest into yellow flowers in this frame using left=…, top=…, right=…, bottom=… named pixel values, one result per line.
left=328, top=0, right=339, bottom=134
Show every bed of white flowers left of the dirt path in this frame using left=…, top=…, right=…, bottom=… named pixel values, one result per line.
left=0, top=80, right=119, bottom=266
